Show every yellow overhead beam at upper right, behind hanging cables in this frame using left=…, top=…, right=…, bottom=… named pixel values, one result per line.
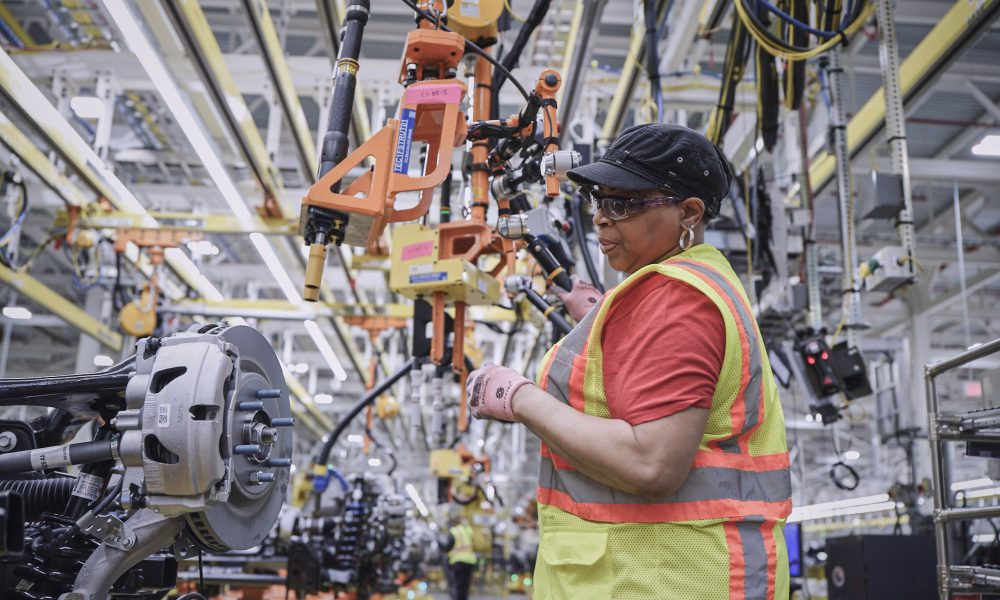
left=809, top=0, right=1000, bottom=195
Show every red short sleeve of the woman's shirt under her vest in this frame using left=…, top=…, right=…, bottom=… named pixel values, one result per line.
left=601, top=273, right=726, bottom=425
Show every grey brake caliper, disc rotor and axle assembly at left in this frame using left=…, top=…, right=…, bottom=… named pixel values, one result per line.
left=0, top=324, right=294, bottom=600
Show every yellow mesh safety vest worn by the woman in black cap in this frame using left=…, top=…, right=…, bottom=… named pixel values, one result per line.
left=535, top=244, right=791, bottom=600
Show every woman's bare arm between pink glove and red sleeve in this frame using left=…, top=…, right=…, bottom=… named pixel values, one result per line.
left=511, top=385, right=708, bottom=499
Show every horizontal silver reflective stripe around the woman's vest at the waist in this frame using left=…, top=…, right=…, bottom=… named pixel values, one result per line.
left=538, top=457, right=792, bottom=504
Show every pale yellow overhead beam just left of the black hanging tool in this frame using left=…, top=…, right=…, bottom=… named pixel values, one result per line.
left=242, top=0, right=319, bottom=181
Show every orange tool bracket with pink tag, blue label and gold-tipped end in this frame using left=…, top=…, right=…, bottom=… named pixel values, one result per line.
left=299, top=2, right=466, bottom=302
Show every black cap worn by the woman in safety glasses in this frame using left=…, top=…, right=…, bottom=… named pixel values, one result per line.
left=567, top=123, right=733, bottom=219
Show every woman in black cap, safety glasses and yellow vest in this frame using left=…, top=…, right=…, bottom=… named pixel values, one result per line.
left=468, top=124, right=791, bottom=600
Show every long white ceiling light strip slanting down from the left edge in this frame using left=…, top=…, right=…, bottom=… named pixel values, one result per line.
left=0, top=49, right=218, bottom=296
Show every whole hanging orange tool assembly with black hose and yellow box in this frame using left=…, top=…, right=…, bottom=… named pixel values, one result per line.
left=300, top=0, right=573, bottom=431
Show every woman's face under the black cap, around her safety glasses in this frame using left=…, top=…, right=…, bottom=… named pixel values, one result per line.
left=594, top=186, right=704, bottom=275
